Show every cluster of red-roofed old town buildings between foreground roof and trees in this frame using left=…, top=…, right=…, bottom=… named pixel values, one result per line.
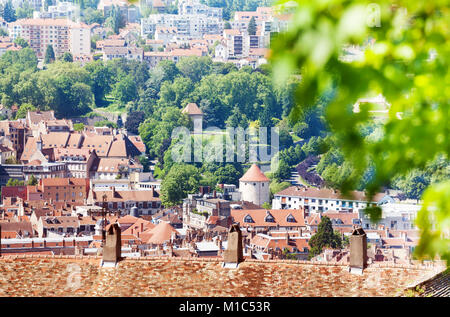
left=0, top=111, right=428, bottom=263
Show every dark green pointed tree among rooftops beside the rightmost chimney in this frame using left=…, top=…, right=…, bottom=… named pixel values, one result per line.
left=309, top=216, right=342, bottom=258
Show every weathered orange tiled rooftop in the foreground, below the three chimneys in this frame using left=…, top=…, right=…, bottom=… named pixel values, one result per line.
left=0, top=255, right=443, bottom=297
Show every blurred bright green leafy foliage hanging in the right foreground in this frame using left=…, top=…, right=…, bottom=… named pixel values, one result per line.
left=271, top=0, right=450, bottom=263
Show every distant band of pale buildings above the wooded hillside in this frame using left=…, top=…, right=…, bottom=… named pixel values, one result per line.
left=0, top=0, right=290, bottom=68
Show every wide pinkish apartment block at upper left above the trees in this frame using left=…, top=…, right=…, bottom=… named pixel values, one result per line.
left=9, top=18, right=91, bottom=59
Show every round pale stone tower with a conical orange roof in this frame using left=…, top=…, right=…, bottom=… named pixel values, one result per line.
left=239, top=164, right=270, bottom=206
